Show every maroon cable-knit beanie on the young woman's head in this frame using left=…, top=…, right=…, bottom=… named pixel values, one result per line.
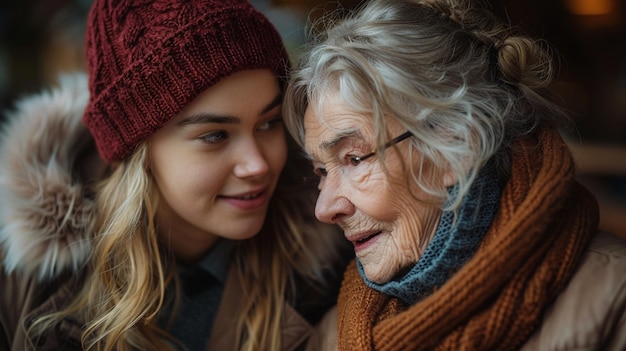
left=83, top=0, right=288, bottom=162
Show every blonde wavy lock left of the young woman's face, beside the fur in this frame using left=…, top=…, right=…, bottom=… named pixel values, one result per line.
left=32, top=144, right=168, bottom=351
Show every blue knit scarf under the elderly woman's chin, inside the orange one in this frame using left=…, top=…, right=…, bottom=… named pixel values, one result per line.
left=357, top=162, right=501, bottom=305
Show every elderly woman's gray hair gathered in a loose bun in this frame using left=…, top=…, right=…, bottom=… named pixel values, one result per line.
left=284, top=0, right=563, bottom=210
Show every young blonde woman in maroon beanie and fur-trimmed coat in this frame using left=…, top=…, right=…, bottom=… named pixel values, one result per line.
left=0, top=0, right=343, bottom=350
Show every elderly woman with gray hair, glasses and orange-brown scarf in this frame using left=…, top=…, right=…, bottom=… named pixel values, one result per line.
left=285, top=0, right=626, bottom=350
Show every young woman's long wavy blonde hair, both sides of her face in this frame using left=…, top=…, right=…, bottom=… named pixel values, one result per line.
left=30, top=133, right=341, bottom=351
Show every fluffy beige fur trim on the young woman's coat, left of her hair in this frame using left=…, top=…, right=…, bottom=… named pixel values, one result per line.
left=0, top=73, right=103, bottom=280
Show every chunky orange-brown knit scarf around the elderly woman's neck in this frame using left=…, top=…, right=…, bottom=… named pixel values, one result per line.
left=338, top=129, right=598, bottom=351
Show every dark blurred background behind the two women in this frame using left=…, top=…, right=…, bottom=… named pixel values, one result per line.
left=0, top=0, right=626, bottom=237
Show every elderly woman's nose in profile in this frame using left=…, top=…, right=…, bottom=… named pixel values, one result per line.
left=315, top=177, right=355, bottom=224
